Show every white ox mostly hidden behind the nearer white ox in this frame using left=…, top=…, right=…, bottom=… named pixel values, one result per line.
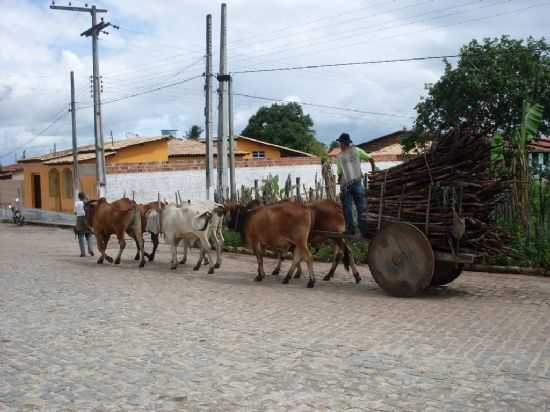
left=180, top=200, right=225, bottom=269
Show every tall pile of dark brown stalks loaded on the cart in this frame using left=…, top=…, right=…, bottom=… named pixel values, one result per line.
left=368, top=130, right=508, bottom=255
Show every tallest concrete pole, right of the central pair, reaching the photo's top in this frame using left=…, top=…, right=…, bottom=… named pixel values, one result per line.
left=218, top=3, right=229, bottom=201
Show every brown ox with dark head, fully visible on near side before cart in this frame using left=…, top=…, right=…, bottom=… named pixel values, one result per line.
left=229, top=202, right=315, bottom=288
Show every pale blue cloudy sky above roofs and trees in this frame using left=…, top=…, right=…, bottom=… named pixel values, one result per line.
left=0, top=0, right=550, bottom=164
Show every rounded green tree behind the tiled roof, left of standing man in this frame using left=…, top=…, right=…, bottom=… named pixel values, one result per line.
left=241, top=102, right=326, bottom=156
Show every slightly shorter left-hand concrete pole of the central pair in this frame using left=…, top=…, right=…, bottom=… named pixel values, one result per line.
left=204, top=14, right=214, bottom=199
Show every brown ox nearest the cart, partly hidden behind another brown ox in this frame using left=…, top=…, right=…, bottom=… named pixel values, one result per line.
left=272, top=199, right=361, bottom=283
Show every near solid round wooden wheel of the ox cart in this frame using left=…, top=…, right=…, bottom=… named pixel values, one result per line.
left=368, top=223, right=435, bottom=297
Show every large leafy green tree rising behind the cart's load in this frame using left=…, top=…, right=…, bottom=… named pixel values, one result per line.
left=412, top=36, right=550, bottom=150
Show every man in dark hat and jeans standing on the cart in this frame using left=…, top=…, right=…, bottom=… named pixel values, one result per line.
left=336, top=133, right=375, bottom=239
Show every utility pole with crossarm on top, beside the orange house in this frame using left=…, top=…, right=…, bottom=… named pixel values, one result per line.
left=50, top=2, right=118, bottom=198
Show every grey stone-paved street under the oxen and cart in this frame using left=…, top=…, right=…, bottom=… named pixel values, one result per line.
left=0, top=224, right=550, bottom=412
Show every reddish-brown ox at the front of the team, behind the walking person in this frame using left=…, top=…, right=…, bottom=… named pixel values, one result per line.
left=85, top=198, right=145, bottom=267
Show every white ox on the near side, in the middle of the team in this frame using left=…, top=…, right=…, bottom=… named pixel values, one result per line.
left=155, top=204, right=218, bottom=273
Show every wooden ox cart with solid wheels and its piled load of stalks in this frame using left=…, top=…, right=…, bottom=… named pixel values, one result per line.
left=314, top=130, right=508, bottom=297
